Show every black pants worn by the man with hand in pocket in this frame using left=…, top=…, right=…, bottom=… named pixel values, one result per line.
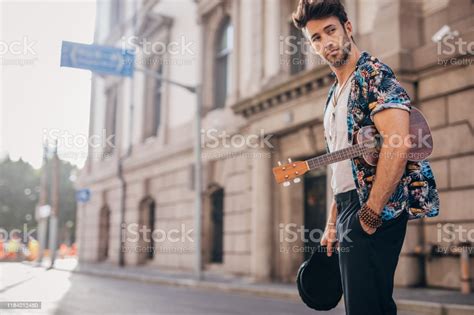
left=335, top=190, right=408, bottom=315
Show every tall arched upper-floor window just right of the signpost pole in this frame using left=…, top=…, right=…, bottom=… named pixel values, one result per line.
left=214, top=18, right=234, bottom=108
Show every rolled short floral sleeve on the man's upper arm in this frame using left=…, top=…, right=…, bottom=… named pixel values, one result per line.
left=369, top=69, right=411, bottom=119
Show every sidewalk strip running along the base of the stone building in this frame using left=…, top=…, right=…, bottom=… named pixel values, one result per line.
left=27, top=258, right=474, bottom=315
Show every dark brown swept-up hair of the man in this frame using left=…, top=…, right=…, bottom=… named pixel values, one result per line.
left=292, top=0, right=348, bottom=30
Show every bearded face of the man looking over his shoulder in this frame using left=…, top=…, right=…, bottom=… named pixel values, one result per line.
left=306, top=16, right=352, bottom=68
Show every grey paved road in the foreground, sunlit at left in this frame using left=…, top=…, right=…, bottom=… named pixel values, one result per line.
left=0, top=263, right=344, bottom=315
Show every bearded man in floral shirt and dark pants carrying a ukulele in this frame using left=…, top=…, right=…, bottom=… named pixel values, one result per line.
left=293, top=0, right=439, bottom=315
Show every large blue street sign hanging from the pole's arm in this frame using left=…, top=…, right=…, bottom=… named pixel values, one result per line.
left=61, top=41, right=135, bottom=77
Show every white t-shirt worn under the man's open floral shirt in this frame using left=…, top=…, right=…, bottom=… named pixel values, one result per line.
left=324, top=76, right=356, bottom=194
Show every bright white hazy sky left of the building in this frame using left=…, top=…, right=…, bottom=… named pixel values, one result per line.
left=0, top=0, right=96, bottom=168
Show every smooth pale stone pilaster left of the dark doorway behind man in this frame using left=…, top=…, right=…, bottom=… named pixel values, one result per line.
left=251, top=149, right=272, bottom=281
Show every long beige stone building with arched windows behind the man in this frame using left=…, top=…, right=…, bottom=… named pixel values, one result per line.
left=77, top=0, right=474, bottom=288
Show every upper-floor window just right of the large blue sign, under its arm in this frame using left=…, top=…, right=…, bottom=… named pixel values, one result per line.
left=144, top=62, right=163, bottom=139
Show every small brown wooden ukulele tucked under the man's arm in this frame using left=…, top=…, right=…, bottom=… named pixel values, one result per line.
left=273, top=107, right=433, bottom=187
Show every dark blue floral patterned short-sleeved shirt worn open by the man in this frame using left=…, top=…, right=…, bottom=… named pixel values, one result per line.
left=324, top=52, right=439, bottom=221
